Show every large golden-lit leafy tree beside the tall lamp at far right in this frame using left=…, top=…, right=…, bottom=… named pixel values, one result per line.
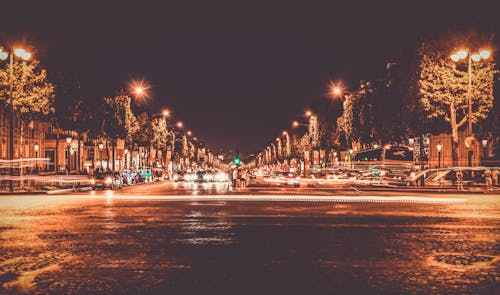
left=419, top=40, right=494, bottom=166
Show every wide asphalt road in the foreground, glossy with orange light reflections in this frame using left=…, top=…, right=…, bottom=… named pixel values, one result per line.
left=0, top=184, right=500, bottom=294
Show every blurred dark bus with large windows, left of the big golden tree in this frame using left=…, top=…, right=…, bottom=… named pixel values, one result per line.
left=353, top=145, right=415, bottom=178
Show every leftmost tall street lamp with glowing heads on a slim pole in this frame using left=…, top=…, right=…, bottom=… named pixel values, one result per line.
left=0, top=47, right=31, bottom=192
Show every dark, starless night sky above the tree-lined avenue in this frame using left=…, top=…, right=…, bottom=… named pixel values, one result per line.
left=0, top=0, right=500, bottom=153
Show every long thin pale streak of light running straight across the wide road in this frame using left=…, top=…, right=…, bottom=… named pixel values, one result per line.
left=92, top=194, right=467, bottom=203
